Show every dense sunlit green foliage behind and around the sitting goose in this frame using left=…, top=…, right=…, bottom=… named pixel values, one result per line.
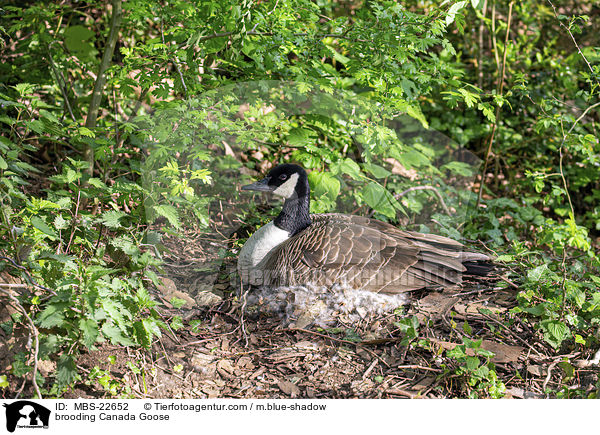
left=0, top=0, right=600, bottom=397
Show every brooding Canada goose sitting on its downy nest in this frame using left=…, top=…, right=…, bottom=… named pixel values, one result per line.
left=238, top=164, right=492, bottom=295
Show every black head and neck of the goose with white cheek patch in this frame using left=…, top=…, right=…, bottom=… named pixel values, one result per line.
left=242, top=163, right=311, bottom=236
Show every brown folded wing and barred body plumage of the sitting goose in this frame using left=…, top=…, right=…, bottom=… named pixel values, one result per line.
left=258, top=214, right=485, bottom=294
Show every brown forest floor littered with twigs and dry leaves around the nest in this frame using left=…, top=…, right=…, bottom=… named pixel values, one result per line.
left=0, top=227, right=598, bottom=398
